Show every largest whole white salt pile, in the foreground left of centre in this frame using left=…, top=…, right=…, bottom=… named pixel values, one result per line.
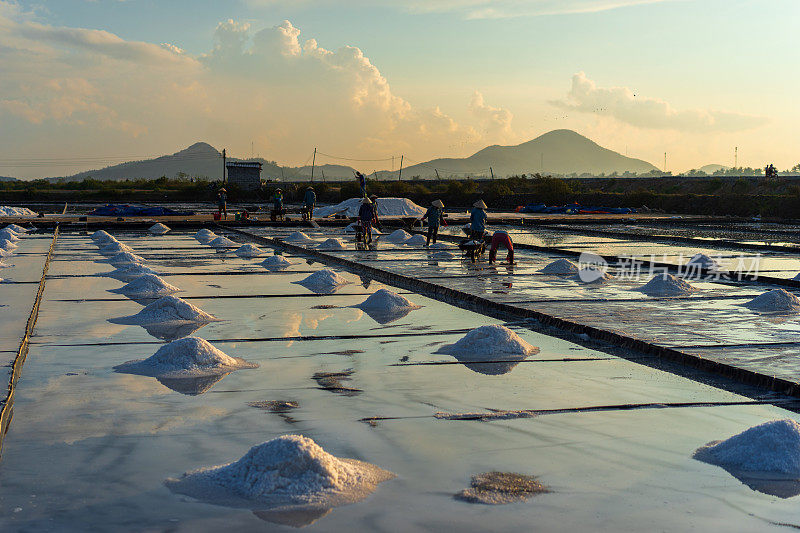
left=165, top=435, right=395, bottom=511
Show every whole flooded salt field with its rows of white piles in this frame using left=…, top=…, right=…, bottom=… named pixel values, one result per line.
left=0, top=223, right=800, bottom=531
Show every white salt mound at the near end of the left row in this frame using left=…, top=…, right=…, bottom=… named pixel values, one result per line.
left=114, top=337, right=258, bottom=378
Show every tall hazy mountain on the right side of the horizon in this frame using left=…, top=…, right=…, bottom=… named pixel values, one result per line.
left=379, top=130, right=658, bottom=178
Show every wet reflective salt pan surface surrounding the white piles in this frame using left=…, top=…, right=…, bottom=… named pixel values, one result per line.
left=0, top=230, right=800, bottom=531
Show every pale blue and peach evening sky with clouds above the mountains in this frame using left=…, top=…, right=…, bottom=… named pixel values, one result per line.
left=0, top=0, right=800, bottom=178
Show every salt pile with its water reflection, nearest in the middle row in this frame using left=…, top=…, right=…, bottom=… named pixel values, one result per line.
left=435, top=325, right=539, bottom=375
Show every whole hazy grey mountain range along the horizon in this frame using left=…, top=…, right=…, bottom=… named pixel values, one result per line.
left=40, top=130, right=658, bottom=181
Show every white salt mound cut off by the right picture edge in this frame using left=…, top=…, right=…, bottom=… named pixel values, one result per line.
left=694, top=418, right=800, bottom=478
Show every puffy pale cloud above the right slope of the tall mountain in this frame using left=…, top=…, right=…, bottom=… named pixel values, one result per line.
left=551, top=72, right=768, bottom=132
